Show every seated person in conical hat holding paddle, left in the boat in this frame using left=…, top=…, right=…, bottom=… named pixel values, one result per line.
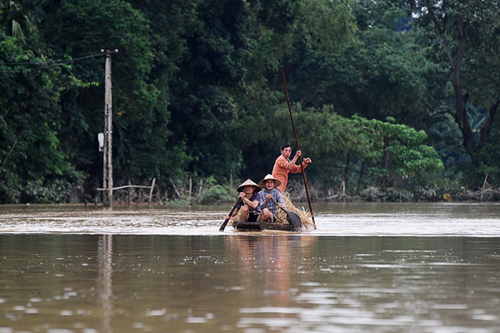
left=226, top=179, right=262, bottom=222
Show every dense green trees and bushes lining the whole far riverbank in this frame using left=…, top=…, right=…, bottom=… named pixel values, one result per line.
left=0, top=0, right=500, bottom=204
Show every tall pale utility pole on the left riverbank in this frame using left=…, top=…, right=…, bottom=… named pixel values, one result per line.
left=101, top=50, right=118, bottom=208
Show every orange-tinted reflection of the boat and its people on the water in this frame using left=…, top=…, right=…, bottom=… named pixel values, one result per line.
left=230, top=235, right=316, bottom=331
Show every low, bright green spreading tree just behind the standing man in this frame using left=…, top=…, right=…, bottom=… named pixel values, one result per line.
left=237, top=104, right=444, bottom=194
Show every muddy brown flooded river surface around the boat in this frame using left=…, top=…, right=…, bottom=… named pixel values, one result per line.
left=0, top=203, right=500, bottom=333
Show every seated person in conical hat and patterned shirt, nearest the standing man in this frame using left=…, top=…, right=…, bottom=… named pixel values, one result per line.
left=257, top=175, right=286, bottom=223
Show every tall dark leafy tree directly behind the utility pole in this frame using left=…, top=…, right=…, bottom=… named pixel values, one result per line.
left=42, top=1, right=169, bottom=195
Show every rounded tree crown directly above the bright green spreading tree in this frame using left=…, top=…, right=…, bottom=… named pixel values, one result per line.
left=280, top=1, right=439, bottom=128
